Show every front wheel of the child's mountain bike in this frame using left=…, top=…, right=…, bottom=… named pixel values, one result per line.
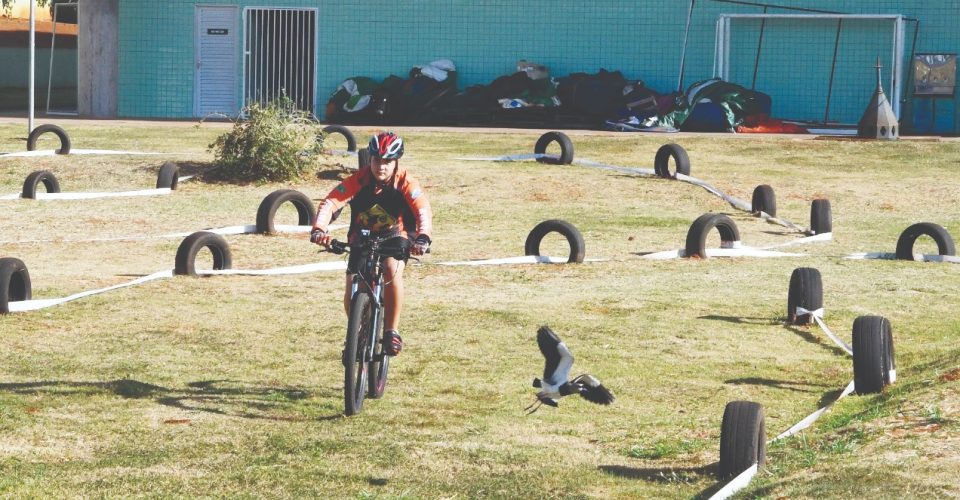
left=343, top=293, right=372, bottom=416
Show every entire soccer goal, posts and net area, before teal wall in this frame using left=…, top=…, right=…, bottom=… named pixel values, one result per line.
left=714, top=14, right=904, bottom=125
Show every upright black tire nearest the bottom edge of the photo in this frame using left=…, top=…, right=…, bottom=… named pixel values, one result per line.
left=719, top=401, right=767, bottom=480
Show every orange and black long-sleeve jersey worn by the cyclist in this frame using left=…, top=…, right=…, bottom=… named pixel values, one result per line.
left=314, top=165, right=433, bottom=240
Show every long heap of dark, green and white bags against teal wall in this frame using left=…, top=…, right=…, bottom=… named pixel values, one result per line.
left=325, top=59, right=788, bottom=132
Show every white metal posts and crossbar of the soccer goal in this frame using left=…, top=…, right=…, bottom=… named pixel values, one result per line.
left=713, top=13, right=906, bottom=122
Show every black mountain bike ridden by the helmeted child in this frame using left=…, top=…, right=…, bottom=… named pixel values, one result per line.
left=318, top=229, right=410, bottom=416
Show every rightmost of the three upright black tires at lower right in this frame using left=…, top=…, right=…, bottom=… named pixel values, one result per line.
left=853, top=316, right=894, bottom=394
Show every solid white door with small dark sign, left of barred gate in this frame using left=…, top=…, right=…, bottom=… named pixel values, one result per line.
left=193, top=6, right=240, bottom=118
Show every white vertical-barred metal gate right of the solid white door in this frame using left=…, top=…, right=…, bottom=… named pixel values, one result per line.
left=243, top=7, right=317, bottom=113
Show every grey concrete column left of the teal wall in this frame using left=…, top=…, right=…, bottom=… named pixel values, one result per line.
left=77, top=0, right=120, bottom=118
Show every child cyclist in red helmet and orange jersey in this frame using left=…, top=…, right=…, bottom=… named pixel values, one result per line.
left=310, top=132, right=433, bottom=356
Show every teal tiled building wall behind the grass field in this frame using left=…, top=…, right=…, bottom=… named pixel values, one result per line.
left=119, top=0, right=960, bottom=132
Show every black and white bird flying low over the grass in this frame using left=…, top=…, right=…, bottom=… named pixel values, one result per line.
left=525, top=325, right=614, bottom=414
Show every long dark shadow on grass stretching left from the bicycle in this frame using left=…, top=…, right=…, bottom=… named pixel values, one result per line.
left=0, top=379, right=342, bottom=421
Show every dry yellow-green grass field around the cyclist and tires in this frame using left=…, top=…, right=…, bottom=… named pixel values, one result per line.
left=0, top=122, right=960, bottom=498
